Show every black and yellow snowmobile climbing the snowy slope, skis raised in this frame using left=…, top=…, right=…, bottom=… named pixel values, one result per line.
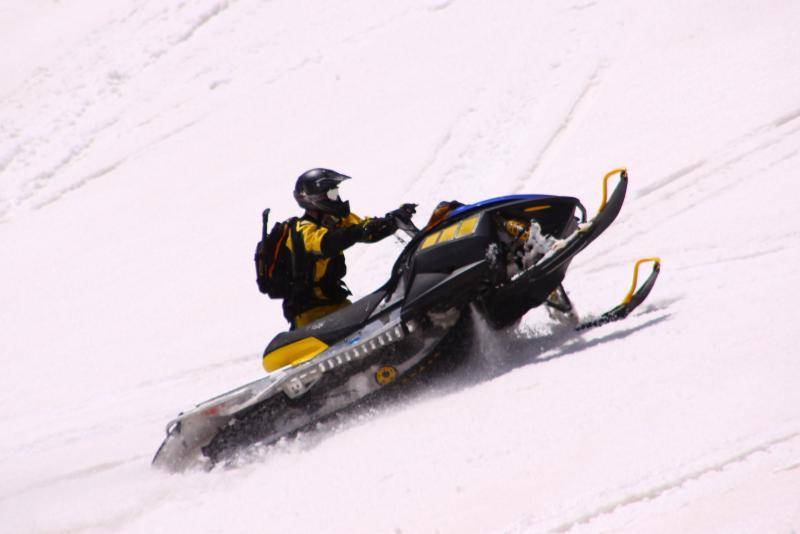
left=153, top=169, right=660, bottom=471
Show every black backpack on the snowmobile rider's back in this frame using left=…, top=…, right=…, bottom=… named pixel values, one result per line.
left=254, top=208, right=302, bottom=299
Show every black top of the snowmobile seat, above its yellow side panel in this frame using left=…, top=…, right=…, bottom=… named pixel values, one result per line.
left=264, top=290, right=386, bottom=356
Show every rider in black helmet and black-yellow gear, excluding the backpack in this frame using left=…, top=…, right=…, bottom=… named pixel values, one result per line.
left=283, top=169, right=416, bottom=330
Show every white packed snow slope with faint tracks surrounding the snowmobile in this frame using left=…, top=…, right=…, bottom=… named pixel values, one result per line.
left=0, top=0, right=800, bottom=533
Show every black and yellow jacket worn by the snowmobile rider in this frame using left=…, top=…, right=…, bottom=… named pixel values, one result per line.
left=283, top=213, right=394, bottom=325
